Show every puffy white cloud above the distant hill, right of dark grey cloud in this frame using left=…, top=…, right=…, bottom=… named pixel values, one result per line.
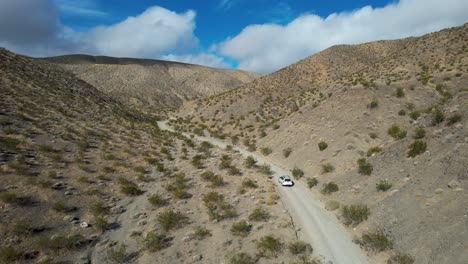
left=85, top=7, right=198, bottom=58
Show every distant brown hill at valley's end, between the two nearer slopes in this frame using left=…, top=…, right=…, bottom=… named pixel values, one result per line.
left=43, top=55, right=259, bottom=111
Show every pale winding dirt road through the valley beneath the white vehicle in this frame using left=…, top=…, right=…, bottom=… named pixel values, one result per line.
left=158, top=121, right=369, bottom=264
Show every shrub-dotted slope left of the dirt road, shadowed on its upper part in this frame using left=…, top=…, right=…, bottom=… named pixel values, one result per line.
left=0, top=49, right=300, bottom=263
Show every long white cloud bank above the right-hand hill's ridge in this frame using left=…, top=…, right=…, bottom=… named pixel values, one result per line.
left=218, top=0, right=468, bottom=73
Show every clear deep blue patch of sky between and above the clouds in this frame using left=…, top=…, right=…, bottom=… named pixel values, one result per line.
left=56, top=0, right=392, bottom=49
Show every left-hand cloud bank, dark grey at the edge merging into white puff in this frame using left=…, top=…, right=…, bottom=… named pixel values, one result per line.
left=0, top=0, right=198, bottom=58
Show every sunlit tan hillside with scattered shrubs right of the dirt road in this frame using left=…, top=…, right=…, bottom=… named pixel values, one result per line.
left=173, top=24, right=468, bottom=264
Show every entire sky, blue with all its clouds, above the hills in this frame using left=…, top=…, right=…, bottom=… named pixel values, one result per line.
left=0, top=0, right=468, bottom=74
